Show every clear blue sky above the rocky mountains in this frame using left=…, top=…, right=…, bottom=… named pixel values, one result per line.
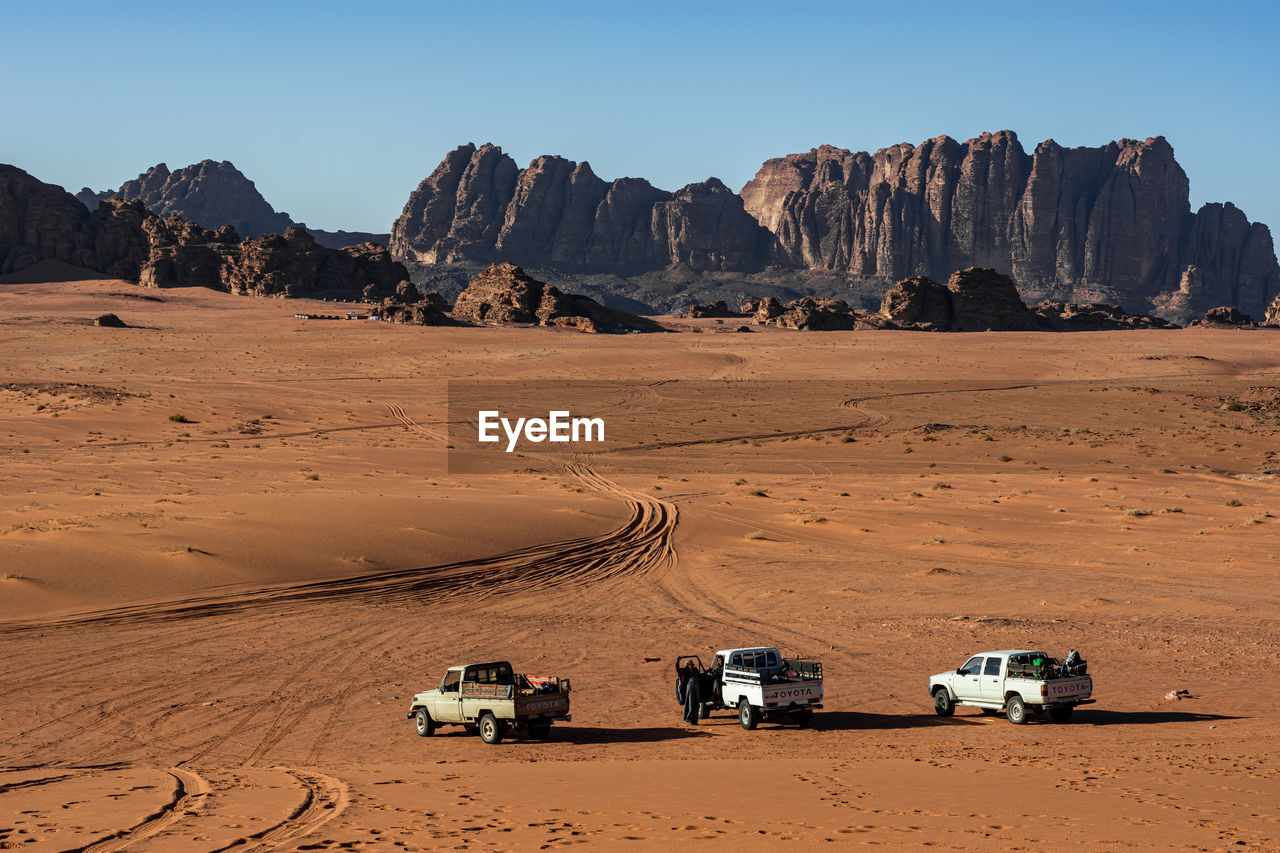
left=0, top=0, right=1280, bottom=231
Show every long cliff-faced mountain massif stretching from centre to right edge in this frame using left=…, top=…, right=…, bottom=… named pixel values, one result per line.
left=390, top=131, right=1280, bottom=321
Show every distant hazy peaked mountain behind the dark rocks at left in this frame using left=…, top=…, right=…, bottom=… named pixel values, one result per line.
left=76, top=160, right=297, bottom=237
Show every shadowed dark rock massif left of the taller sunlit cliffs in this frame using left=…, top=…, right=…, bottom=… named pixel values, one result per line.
left=390, top=145, right=774, bottom=274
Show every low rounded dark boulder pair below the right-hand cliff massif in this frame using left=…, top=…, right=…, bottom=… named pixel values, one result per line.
left=881, top=268, right=1037, bottom=332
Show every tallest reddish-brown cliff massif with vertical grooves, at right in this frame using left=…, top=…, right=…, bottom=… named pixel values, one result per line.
left=741, top=131, right=1280, bottom=314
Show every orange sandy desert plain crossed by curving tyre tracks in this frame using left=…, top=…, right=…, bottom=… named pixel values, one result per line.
left=0, top=279, right=1280, bottom=853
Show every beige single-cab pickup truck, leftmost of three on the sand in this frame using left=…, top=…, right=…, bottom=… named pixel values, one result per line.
left=406, top=661, right=572, bottom=743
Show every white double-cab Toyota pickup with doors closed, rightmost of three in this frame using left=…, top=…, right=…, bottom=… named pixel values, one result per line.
left=929, top=649, right=1093, bottom=725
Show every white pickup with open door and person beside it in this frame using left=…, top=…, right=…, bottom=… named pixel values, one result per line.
left=676, top=647, right=822, bottom=730
